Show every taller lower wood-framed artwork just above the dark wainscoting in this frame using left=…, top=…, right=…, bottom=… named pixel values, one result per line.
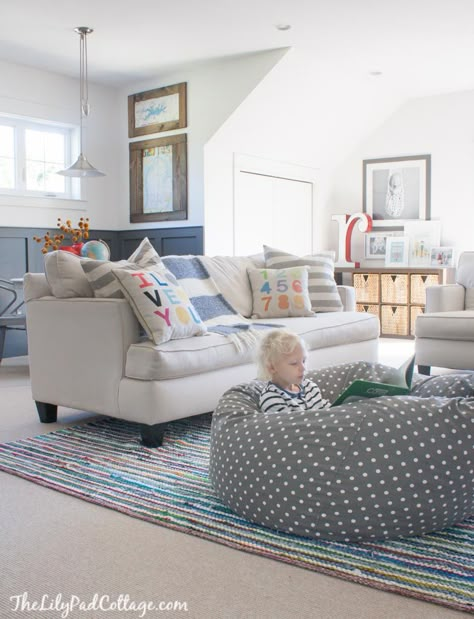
left=129, top=133, right=188, bottom=223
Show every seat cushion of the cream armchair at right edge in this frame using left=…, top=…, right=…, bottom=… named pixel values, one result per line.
left=416, top=310, right=474, bottom=342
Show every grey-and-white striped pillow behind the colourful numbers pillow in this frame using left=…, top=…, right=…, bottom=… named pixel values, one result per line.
left=263, top=245, right=343, bottom=312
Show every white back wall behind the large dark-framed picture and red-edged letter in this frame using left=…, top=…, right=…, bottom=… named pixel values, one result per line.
left=326, top=91, right=474, bottom=265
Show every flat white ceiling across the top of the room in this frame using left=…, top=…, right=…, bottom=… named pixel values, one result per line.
left=0, top=0, right=474, bottom=96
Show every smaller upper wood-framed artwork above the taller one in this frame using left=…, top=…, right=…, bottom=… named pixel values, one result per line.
left=128, top=82, right=187, bottom=138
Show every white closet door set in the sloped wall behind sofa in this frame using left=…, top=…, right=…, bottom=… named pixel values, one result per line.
left=234, top=171, right=313, bottom=256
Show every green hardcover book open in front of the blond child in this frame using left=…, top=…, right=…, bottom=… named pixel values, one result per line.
left=331, top=355, right=415, bottom=407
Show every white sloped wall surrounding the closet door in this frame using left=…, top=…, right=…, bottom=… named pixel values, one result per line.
left=204, top=49, right=403, bottom=254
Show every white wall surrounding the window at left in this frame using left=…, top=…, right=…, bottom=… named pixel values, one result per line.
left=0, top=61, right=120, bottom=230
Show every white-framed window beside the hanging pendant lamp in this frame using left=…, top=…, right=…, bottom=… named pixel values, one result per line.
left=0, top=116, right=77, bottom=198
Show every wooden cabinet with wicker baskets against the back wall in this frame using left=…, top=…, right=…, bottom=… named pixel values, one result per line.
left=346, top=268, right=454, bottom=337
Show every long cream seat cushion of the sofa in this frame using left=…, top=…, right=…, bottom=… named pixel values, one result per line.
left=125, top=312, right=379, bottom=380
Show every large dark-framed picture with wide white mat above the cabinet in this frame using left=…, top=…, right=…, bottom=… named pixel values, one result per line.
left=363, top=155, right=431, bottom=227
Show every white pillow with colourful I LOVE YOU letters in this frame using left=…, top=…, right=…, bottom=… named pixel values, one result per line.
left=112, top=267, right=207, bottom=344
